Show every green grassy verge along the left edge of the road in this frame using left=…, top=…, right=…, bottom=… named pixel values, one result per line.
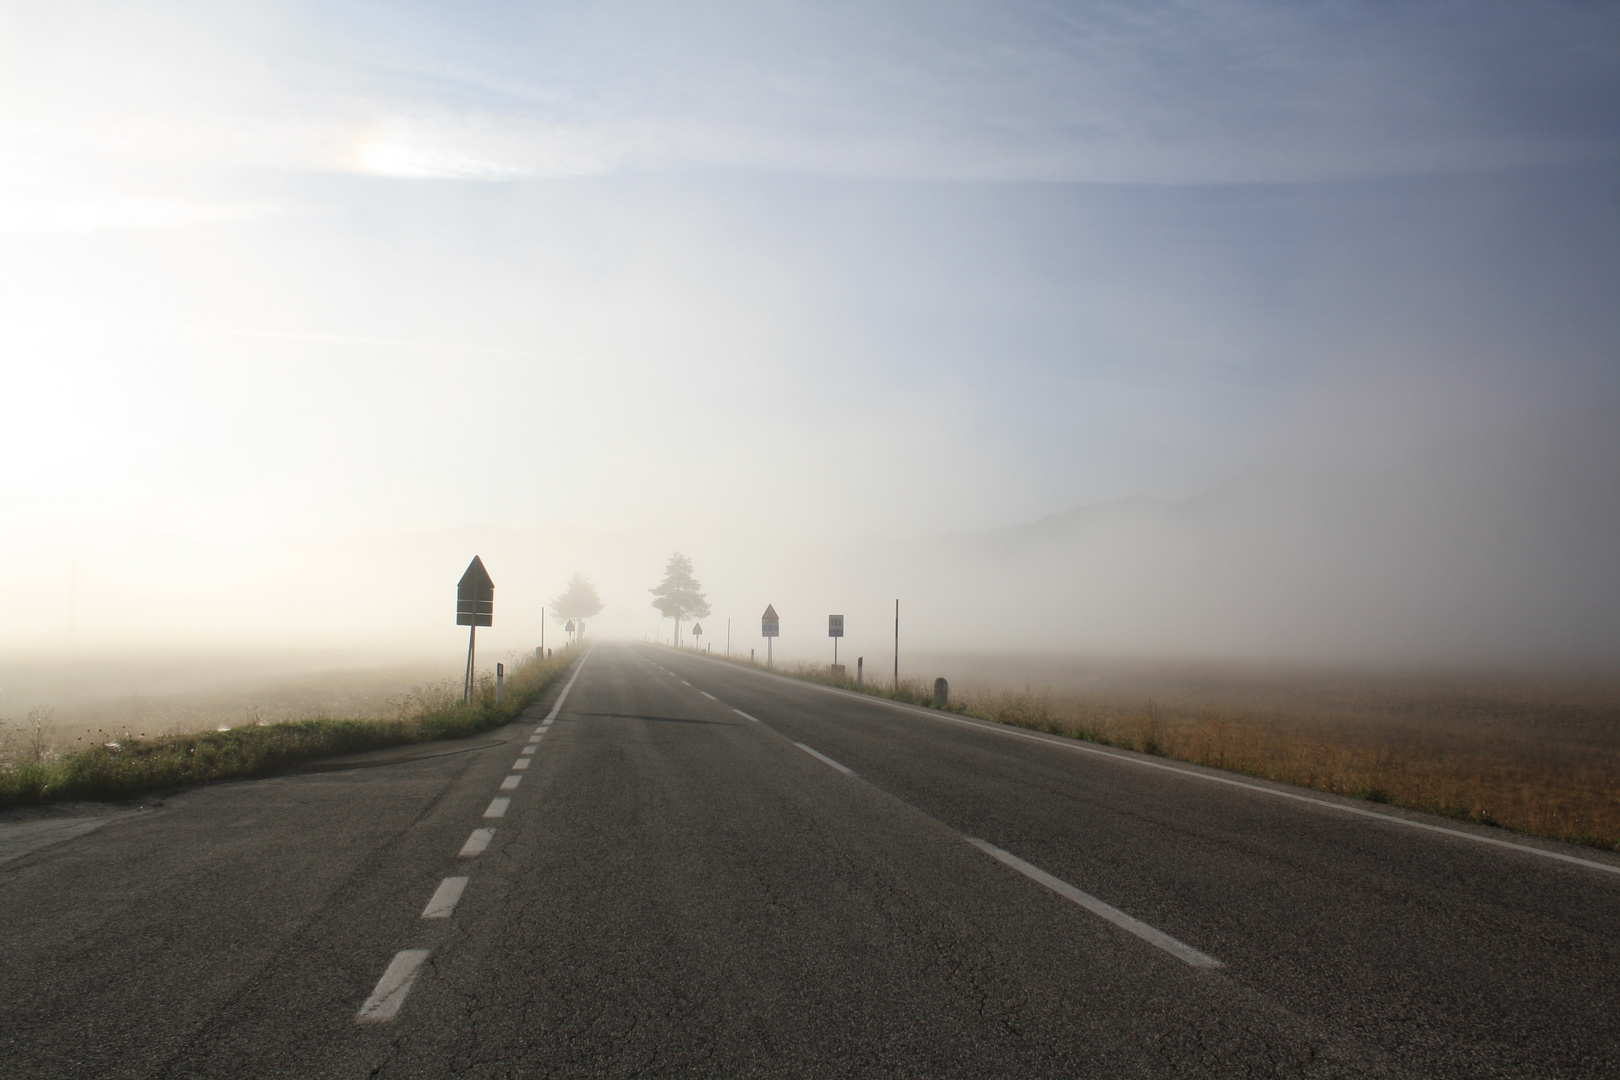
left=0, top=651, right=577, bottom=808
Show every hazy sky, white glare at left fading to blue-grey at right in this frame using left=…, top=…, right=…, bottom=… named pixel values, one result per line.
left=0, top=0, right=1620, bottom=648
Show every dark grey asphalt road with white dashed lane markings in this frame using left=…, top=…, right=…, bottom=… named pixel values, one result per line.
left=0, top=646, right=1620, bottom=1078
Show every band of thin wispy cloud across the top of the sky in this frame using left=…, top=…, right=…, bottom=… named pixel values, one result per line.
left=0, top=0, right=1620, bottom=200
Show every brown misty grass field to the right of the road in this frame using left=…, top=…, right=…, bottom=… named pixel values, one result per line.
left=761, top=656, right=1620, bottom=850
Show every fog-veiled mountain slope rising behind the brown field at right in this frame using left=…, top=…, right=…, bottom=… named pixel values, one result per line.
left=889, top=408, right=1620, bottom=662
